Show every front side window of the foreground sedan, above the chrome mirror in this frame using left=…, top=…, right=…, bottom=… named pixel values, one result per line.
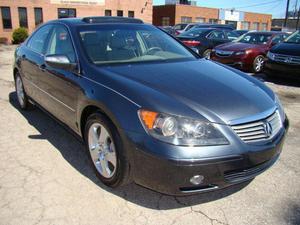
left=47, top=25, right=76, bottom=63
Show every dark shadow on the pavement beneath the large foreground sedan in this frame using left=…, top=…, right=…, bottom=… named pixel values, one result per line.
left=9, top=92, right=251, bottom=210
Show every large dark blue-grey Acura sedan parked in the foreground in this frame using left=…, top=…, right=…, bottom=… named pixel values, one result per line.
left=13, top=17, right=288, bottom=195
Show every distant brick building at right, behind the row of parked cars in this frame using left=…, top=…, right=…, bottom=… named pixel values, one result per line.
left=153, top=4, right=272, bottom=30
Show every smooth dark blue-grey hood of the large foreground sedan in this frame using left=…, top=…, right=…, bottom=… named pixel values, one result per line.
left=97, top=59, right=274, bottom=124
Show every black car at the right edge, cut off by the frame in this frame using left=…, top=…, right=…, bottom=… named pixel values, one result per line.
left=264, top=31, right=300, bottom=79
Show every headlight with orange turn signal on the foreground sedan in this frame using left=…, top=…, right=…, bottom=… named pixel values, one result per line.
left=138, top=110, right=229, bottom=146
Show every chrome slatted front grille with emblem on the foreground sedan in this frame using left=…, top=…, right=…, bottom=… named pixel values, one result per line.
left=231, top=110, right=282, bottom=143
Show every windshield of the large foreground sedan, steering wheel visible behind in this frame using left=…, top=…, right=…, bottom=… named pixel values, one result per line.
left=79, top=24, right=196, bottom=64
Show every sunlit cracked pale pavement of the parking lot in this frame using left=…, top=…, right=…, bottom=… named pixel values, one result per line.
left=0, top=45, right=300, bottom=225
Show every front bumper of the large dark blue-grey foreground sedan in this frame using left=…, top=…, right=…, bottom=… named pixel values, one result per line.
left=123, top=118, right=288, bottom=195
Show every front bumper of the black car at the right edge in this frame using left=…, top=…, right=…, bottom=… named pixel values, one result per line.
left=264, top=59, right=300, bottom=79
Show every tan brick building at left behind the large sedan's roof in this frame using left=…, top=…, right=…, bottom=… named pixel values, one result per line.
left=0, top=0, right=152, bottom=41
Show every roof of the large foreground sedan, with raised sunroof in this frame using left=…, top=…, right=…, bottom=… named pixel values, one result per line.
left=49, top=16, right=144, bottom=26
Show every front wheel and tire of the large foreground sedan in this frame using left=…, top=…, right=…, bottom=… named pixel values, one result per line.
left=85, top=113, right=130, bottom=188
